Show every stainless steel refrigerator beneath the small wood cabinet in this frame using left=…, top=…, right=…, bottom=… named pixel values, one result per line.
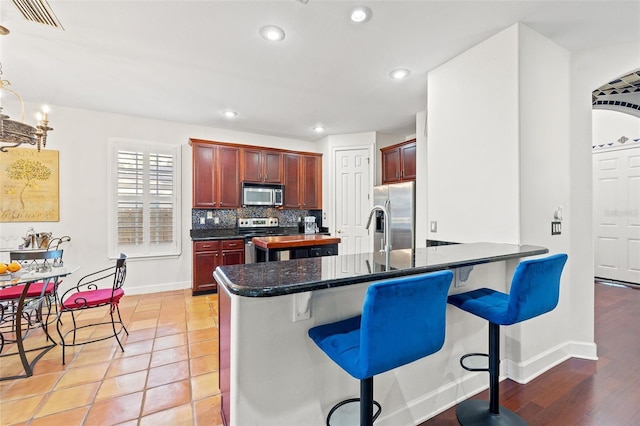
left=373, top=182, right=416, bottom=251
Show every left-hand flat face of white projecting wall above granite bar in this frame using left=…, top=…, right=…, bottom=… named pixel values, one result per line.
left=427, top=26, right=519, bottom=243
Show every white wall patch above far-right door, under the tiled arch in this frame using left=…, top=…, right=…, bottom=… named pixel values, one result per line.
left=592, top=109, right=640, bottom=146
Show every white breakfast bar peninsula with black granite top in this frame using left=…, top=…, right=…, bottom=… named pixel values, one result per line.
left=214, top=243, right=548, bottom=425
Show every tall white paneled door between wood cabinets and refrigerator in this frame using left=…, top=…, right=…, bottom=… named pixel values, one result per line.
left=334, top=148, right=371, bottom=254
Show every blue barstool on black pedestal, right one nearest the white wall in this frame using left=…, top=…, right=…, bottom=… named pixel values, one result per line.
left=448, top=254, right=567, bottom=426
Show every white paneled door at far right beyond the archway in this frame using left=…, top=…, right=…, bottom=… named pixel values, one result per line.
left=593, top=147, right=640, bottom=284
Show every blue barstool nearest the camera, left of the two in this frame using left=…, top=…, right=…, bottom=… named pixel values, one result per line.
left=309, top=271, right=453, bottom=426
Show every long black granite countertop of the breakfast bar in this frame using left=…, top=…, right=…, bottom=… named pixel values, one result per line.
left=214, top=243, right=549, bottom=297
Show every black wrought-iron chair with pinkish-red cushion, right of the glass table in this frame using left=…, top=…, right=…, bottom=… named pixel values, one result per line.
left=56, top=254, right=129, bottom=365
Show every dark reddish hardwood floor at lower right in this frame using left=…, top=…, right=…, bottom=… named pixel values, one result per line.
left=420, top=283, right=640, bottom=426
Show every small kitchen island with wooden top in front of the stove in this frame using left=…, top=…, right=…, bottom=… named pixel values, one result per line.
left=252, top=234, right=340, bottom=262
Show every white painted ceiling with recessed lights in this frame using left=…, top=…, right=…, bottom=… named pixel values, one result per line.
left=0, top=0, right=640, bottom=141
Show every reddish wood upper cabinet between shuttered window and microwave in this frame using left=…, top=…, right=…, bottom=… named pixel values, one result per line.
left=191, top=139, right=241, bottom=209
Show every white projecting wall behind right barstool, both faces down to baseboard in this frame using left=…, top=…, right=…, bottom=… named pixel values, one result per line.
left=427, top=24, right=640, bottom=382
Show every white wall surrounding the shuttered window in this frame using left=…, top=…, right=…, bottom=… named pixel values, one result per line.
left=0, top=105, right=318, bottom=294
